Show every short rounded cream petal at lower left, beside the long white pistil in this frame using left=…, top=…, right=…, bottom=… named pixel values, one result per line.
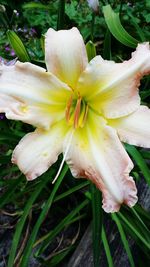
left=12, top=121, right=67, bottom=180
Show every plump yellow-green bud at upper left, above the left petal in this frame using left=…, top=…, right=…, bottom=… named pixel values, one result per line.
left=7, top=30, right=31, bottom=62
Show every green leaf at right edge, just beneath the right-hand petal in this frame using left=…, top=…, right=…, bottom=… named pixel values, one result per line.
left=125, top=144, right=150, bottom=185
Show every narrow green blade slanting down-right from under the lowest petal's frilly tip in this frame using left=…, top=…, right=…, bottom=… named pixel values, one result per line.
left=111, top=213, right=135, bottom=267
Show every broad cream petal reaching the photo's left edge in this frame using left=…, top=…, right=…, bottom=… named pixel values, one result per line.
left=0, top=62, right=70, bottom=128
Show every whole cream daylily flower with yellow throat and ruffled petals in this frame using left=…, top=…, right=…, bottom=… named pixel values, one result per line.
left=0, top=28, right=150, bottom=212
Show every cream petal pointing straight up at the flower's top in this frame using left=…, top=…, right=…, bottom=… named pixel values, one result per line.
left=45, top=28, right=88, bottom=89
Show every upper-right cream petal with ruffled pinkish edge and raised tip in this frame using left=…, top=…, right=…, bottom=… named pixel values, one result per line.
left=77, top=43, right=150, bottom=118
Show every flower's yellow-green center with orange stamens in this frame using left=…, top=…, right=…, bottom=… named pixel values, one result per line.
left=66, top=95, right=89, bottom=128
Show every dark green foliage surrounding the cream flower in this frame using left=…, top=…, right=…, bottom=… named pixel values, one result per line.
left=0, top=0, right=150, bottom=267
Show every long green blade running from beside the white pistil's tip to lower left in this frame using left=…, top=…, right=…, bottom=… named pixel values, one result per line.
left=21, top=165, right=68, bottom=267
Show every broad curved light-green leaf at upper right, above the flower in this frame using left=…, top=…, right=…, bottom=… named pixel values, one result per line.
left=103, top=5, right=139, bottom=48
